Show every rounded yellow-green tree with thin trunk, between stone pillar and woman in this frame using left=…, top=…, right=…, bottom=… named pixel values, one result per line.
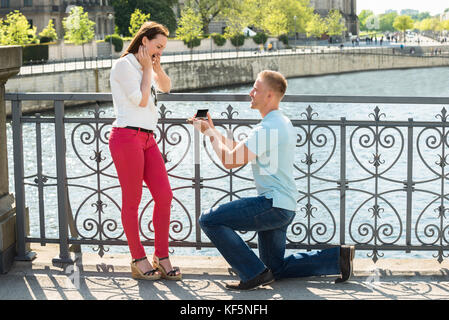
left=62, top=6, right=95, bottom=66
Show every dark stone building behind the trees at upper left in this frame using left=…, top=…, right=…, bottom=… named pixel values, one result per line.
left=0, top=0, right=114, bottom=39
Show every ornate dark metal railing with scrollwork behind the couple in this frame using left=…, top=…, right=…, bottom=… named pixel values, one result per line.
left=6, top=93, right=449, bottom=263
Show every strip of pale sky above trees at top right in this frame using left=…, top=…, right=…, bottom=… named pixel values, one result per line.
left=357, top=0, right=449, bottom=15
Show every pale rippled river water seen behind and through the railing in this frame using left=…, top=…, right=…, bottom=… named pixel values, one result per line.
left=7, top=68, right=449, bottom=258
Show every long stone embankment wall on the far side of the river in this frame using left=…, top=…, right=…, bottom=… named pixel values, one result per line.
left=6, top=51, right=449, bottom=115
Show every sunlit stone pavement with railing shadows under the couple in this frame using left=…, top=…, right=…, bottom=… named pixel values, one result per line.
left=0, top=245, right=449, bottom=300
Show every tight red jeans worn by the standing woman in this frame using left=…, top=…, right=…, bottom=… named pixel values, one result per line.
left=109, top=127, right=173, bottom=259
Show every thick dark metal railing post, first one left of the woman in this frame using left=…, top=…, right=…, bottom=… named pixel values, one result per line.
left=52, top=100, right=76, bottom=266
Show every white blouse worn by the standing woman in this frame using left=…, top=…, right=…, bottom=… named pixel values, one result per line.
left=109, top=53, right=158, bottom=130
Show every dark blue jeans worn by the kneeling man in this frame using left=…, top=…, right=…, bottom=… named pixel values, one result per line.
left=199, top=196, right=340, bottom=281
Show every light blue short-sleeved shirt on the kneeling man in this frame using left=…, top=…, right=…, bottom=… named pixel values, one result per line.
left=244, top=110, right=298, bottom=211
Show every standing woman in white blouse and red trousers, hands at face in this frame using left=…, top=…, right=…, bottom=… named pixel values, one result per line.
left=109, top=22, right=181, bottom=280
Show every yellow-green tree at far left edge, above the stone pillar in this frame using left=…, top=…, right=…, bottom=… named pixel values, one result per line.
left=0, top=10, right=36, bottom=45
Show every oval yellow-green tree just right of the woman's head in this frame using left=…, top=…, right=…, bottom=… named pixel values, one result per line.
left=176, top=7, right=203, bottom=53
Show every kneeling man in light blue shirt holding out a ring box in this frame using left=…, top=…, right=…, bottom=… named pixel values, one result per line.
left=190, top=70, right=354, bottom=290
